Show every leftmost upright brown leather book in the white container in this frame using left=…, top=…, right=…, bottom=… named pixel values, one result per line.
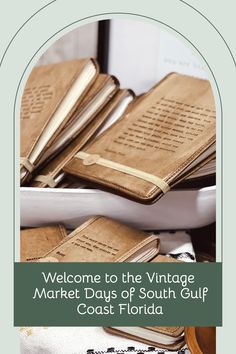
left=20, top=58, right=98, bottom=183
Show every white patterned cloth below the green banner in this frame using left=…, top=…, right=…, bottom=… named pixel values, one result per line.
left=20, top=327, right=189, bottom=354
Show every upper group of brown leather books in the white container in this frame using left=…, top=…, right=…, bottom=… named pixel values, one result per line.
left=20, top=58, right=215, bottom=204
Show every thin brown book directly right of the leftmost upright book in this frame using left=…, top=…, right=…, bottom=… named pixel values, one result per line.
left=36, top=74, right=119, bottom=168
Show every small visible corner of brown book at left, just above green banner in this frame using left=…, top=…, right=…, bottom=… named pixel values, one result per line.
left=20, top=225, right=67, bottom=262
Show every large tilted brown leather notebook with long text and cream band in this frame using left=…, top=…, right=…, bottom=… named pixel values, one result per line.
left=64, top=73, right=216, bottom=203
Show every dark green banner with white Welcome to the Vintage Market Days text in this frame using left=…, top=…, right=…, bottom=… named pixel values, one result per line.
left=14, top=263, right=222, bottom=326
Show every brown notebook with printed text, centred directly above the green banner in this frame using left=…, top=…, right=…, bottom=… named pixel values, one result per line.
left=40, top=216, right=159, bottom=262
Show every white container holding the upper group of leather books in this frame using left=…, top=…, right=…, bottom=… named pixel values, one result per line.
left=21, top=186, right=216, bottom=230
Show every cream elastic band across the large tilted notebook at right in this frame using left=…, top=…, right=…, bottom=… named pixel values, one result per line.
left=75, top=151, right=170, bottom=193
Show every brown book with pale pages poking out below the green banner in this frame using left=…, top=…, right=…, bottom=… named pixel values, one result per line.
left=104, top=326, right=185, bottom=350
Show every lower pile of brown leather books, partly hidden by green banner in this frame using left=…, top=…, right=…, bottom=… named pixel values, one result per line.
left=20, top=216, right=193, bottom=350
